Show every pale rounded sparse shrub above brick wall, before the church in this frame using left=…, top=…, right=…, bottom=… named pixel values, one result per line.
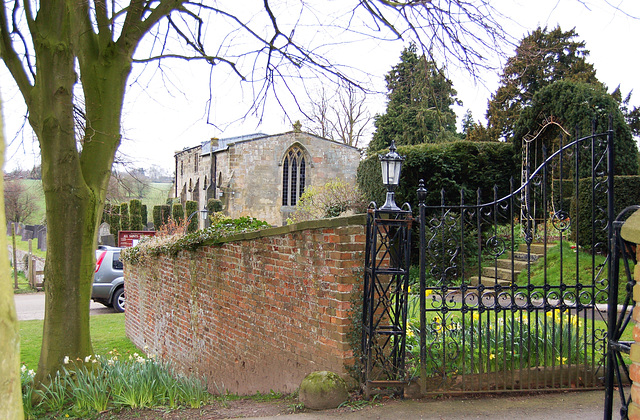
left=287, top=179, right=366, bottom=224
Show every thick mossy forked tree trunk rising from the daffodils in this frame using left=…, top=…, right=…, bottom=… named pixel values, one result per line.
left=29, top=0, right=131, bottom=383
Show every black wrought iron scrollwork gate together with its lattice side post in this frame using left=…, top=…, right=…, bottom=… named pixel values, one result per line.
left=362, top=122, right=624, bottom=394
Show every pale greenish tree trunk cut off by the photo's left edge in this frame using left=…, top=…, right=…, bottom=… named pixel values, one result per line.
left=0, top=96, right=24, bottom=420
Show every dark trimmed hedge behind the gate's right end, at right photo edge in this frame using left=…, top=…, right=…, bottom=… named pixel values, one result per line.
left=571, top=175, right=640, bottom=251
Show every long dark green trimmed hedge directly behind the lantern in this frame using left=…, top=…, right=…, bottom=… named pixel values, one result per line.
left=357, top=141, right=520, bottom=211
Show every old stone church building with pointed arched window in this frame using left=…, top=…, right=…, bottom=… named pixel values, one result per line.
left=174, top=130, right=360, bottom=226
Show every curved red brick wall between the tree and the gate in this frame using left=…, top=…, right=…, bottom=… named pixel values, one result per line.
left=125, top=215, right=365, bottom=394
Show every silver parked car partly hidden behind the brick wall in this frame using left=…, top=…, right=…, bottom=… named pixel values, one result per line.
left=91, top=246, right=125, bottom=312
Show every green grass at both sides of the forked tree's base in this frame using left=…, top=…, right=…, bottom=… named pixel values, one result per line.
left=20, top=313, right=143, bottom=370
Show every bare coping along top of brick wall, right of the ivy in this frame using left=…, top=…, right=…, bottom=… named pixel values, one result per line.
left=210, top=213, right=367, bottom=246
